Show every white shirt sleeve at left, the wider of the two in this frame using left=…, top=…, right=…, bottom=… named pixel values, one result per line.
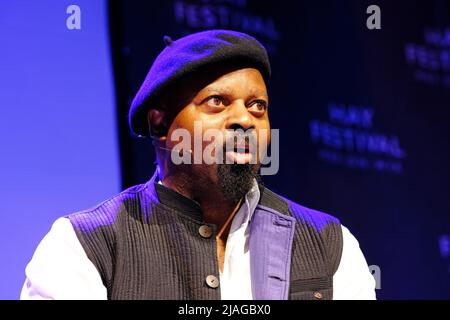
left=20, top=218, right=107, bottom=300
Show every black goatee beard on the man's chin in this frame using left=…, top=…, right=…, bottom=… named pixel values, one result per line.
left=217, top=163, right=260, bottom=202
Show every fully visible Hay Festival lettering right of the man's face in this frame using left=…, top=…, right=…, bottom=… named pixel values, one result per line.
left=310, top=103, right=406, bottom=174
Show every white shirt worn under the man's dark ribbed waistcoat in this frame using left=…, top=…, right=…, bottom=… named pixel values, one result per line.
left=20, top=181, right=376, bottom=300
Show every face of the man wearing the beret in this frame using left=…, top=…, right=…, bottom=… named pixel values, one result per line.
left=162, top=68, right=270, bottom=199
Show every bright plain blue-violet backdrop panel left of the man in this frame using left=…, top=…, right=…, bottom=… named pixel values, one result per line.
left=0, top=0, right=120, bottom=299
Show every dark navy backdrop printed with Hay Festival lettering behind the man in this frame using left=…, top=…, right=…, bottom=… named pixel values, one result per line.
left=110, top=0, right=450, bottom=299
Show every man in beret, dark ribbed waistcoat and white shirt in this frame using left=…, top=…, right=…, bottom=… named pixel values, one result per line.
left=21, top=30, right=375, bottom=300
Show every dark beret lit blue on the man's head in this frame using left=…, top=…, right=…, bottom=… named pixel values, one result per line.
left=128, top=30, right=270, bottom=136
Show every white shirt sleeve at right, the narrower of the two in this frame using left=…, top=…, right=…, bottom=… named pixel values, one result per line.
left=333, top=226, right=376, bottom=300
